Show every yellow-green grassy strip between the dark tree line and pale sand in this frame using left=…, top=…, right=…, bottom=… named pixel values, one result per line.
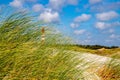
left=65, top=45, right=120, bottom=59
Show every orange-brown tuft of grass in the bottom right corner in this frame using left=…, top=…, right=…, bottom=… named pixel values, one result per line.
left=98, top=59, right=120, bottom=80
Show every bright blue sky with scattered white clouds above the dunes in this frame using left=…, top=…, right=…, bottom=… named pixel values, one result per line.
left=0, top=0, right=120, bottom=46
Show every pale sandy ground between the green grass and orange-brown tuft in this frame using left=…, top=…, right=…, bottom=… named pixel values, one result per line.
left=71, top=51, right=120, bottom=80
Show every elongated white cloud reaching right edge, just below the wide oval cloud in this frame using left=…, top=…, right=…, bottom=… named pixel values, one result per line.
left=95, top=22, right=120, bottom=30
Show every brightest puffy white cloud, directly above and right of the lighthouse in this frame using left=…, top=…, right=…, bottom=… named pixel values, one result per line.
left=38, top=9, right=59, bottom=23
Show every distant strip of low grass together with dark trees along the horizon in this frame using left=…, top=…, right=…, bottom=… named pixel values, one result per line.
left=64, top=45, right=120, bottom=59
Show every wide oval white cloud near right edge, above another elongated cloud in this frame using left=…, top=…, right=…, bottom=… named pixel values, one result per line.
left=96, top=11, right=119, bottom=21
